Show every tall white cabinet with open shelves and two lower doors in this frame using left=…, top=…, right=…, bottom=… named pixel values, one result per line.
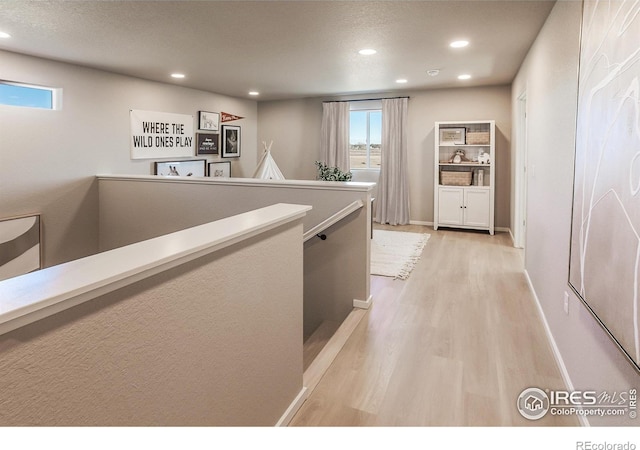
left=433, top=120, right=496, bottom=235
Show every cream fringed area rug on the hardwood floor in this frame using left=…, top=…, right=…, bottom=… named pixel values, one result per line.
left=371, top=230, right=430, bottom=280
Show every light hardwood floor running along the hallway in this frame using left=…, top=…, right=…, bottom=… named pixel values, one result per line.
left=290, top=226, right=578, bottom=426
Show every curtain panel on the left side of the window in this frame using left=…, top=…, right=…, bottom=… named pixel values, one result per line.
left=320, top=102, right=349, bottom=172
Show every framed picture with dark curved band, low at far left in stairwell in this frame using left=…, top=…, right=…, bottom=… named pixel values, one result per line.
left=0, top=214, right=42, bottom=281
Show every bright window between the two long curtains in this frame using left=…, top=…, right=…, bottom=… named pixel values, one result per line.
left=349, top=108, right=382, bottom=169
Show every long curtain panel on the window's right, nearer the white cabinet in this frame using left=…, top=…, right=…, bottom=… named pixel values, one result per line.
left=375, top=98, right=409, bottom=225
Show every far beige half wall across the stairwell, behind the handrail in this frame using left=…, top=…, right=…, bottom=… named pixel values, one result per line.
left=99, top=176, right=371, bottom=339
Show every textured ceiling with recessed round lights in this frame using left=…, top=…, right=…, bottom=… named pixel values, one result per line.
left=0, top=0, right=554, bottom=100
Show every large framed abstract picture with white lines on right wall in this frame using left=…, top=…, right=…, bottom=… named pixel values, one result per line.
left=569, top=2, right=640, bottom=373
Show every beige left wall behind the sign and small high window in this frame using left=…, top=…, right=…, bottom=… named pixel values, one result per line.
left=0, top=51, right=259, bottom=266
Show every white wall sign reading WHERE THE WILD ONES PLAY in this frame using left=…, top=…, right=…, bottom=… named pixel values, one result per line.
left=130, top=110, right=194, bottom=159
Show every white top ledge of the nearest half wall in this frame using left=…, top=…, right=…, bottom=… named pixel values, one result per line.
left=0, top=203, right=311, bottom=335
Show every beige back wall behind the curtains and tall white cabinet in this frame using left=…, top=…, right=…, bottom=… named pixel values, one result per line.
left=258, top=86, right=511, bottom=227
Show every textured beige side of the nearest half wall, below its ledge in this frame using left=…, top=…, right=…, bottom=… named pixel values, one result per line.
left=0, top=219, right=303, bottom=424
